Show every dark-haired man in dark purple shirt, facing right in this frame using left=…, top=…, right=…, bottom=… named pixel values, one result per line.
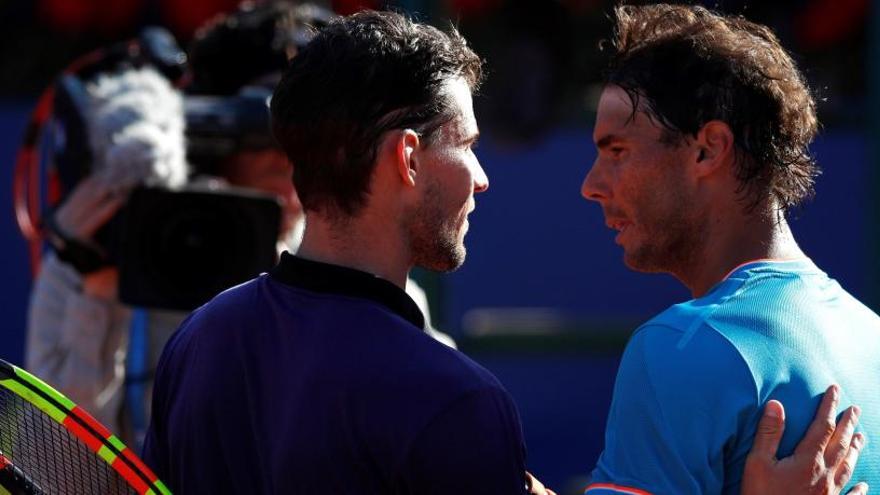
left=145, top=12, right=526, bottom=494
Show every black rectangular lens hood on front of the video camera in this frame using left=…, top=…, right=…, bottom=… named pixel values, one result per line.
left=115, top=188, right=281, bottom=311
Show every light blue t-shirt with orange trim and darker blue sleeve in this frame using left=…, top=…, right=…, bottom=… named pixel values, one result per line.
left=586, top=259, right=880, bottom=495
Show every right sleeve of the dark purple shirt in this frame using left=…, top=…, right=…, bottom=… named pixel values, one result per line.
left=401, top=388, right=525, bottom=495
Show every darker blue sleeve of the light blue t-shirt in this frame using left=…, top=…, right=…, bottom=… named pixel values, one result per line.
left=585, top=326, right=757, bottom=495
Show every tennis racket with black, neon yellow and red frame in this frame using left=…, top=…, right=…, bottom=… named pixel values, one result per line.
left=0, top=359, right=171, bottom=495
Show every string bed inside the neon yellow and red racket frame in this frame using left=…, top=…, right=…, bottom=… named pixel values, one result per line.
left=0, top=387, right=136, bottom=495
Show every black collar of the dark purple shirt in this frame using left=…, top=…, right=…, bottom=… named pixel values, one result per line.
left=269, top=252, right=425, bottom=329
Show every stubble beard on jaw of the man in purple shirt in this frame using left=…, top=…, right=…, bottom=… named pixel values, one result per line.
left=406, top=179, right=467, bottom=272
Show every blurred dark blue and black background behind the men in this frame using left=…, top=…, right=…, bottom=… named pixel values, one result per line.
left=0, top=0, right=880, bottom=494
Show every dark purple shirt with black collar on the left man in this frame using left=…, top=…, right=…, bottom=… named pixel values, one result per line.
left=144, top=253, right=525, bottom=495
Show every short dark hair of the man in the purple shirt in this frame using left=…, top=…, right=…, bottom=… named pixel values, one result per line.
left=271, top=11, right=482, bottom=216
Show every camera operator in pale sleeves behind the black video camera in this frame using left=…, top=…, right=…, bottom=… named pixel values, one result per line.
left=26, top=3, right=334, bottom=446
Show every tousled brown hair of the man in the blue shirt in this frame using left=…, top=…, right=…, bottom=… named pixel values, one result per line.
left=605, top=4, right=819, bottom=210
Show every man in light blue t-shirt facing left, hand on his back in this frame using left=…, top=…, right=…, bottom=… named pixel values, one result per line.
left=582, top=5, right=880, bottom=495
